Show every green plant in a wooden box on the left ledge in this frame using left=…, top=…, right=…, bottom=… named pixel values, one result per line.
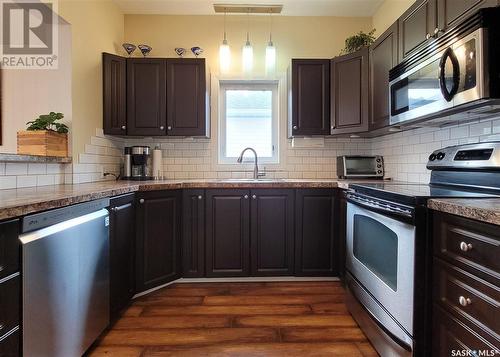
left=17, top=112, right=68, bottom=157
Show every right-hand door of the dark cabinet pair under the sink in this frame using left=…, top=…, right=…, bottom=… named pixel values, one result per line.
left=250, top=190, right=294, bottom=276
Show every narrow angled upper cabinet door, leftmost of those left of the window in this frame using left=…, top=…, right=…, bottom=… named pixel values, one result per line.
left=102, top=53, right=127, bottom=135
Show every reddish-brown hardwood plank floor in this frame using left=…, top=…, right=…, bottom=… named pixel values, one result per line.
left=89, top=282, right=378, bottom=357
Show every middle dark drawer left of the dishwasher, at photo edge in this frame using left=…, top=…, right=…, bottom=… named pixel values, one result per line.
left=0, top=276, right=21, bottom=336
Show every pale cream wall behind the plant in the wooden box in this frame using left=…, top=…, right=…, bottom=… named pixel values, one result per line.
left=0, top=23, right=72, bottom=154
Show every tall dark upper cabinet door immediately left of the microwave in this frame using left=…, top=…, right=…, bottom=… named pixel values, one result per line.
left=370, top=22, right=398, bottom=130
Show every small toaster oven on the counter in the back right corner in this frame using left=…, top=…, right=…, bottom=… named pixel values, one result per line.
left=337, top=155, right=384, bottom=178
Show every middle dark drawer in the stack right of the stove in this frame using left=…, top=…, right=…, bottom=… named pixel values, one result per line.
left=434, top=259, right=500, bottom=335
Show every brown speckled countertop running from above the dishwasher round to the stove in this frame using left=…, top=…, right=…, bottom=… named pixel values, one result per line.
left=0, top=179, right=397, bottom=220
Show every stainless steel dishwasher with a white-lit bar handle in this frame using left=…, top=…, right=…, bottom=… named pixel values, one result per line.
left=20, top=199, right=109, bottom=357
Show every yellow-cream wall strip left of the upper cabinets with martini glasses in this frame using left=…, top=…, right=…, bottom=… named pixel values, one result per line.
left=59, top=0, right=124, bottom=158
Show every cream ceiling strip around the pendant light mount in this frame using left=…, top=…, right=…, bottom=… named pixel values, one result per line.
left=113, top=0, right=383, bottom=16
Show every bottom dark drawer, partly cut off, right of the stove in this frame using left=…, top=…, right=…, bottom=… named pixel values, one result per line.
left=432, top=304, right=499, bottom=357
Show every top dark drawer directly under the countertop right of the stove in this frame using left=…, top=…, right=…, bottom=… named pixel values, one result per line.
left=434, top=213, right=500, bottom=285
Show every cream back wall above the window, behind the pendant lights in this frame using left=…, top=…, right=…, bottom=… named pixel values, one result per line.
left=125, top=15, right=371, bottom=75
